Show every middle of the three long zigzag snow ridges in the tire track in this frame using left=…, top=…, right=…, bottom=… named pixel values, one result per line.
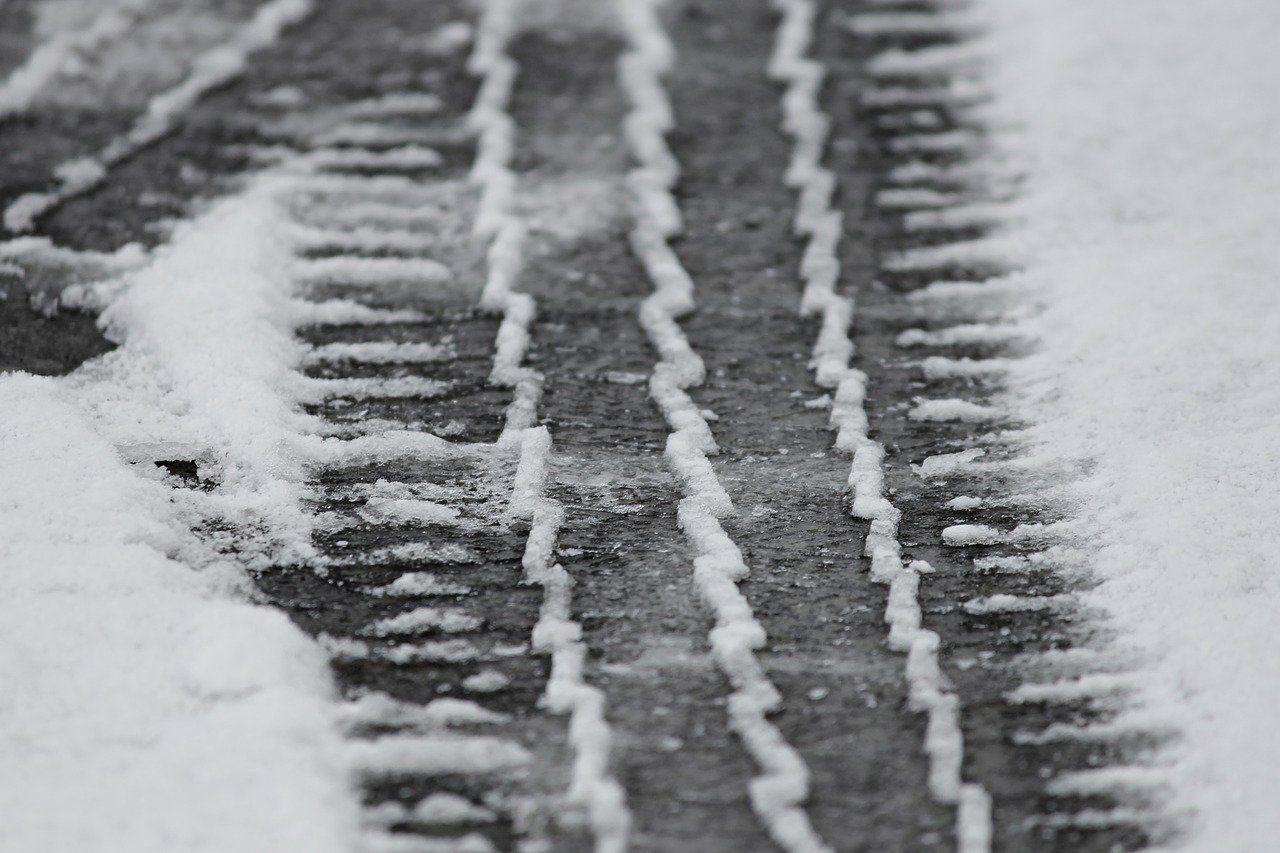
left=616, top=0, right=831, bottom=853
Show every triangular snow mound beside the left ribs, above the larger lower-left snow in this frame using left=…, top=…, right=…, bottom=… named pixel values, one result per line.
left=80, top=178, right=317, bottom=558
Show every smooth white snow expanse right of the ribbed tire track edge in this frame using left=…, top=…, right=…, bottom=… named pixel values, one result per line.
left=977, top=0, right=1280, bottom=853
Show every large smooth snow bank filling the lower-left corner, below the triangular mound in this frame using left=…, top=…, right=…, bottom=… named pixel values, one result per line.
left=0, top=375, right=356, bottom=853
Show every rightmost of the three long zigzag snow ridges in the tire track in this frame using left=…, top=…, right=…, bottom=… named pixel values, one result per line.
left=768, top=0, right=992, bottom=853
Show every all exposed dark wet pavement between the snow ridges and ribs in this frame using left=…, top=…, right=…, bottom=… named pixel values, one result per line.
left=0, top=0, right=1162, bottom=853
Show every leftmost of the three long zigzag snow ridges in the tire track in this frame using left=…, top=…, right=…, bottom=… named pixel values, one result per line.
left=467, top=0, right=631, bottom=853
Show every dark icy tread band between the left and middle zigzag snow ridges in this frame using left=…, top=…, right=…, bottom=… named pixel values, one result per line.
left=512, top=21, right=768, bottom=853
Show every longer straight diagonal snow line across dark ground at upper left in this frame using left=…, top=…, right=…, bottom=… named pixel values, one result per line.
left=4, top=0, right=314, bottom=232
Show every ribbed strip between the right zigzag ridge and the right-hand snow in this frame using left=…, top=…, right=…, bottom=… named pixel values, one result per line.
left=822, top=4, right=1165, bottom=850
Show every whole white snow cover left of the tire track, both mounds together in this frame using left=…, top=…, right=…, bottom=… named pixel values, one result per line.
left=0, top=178, right=358, bottom=853
